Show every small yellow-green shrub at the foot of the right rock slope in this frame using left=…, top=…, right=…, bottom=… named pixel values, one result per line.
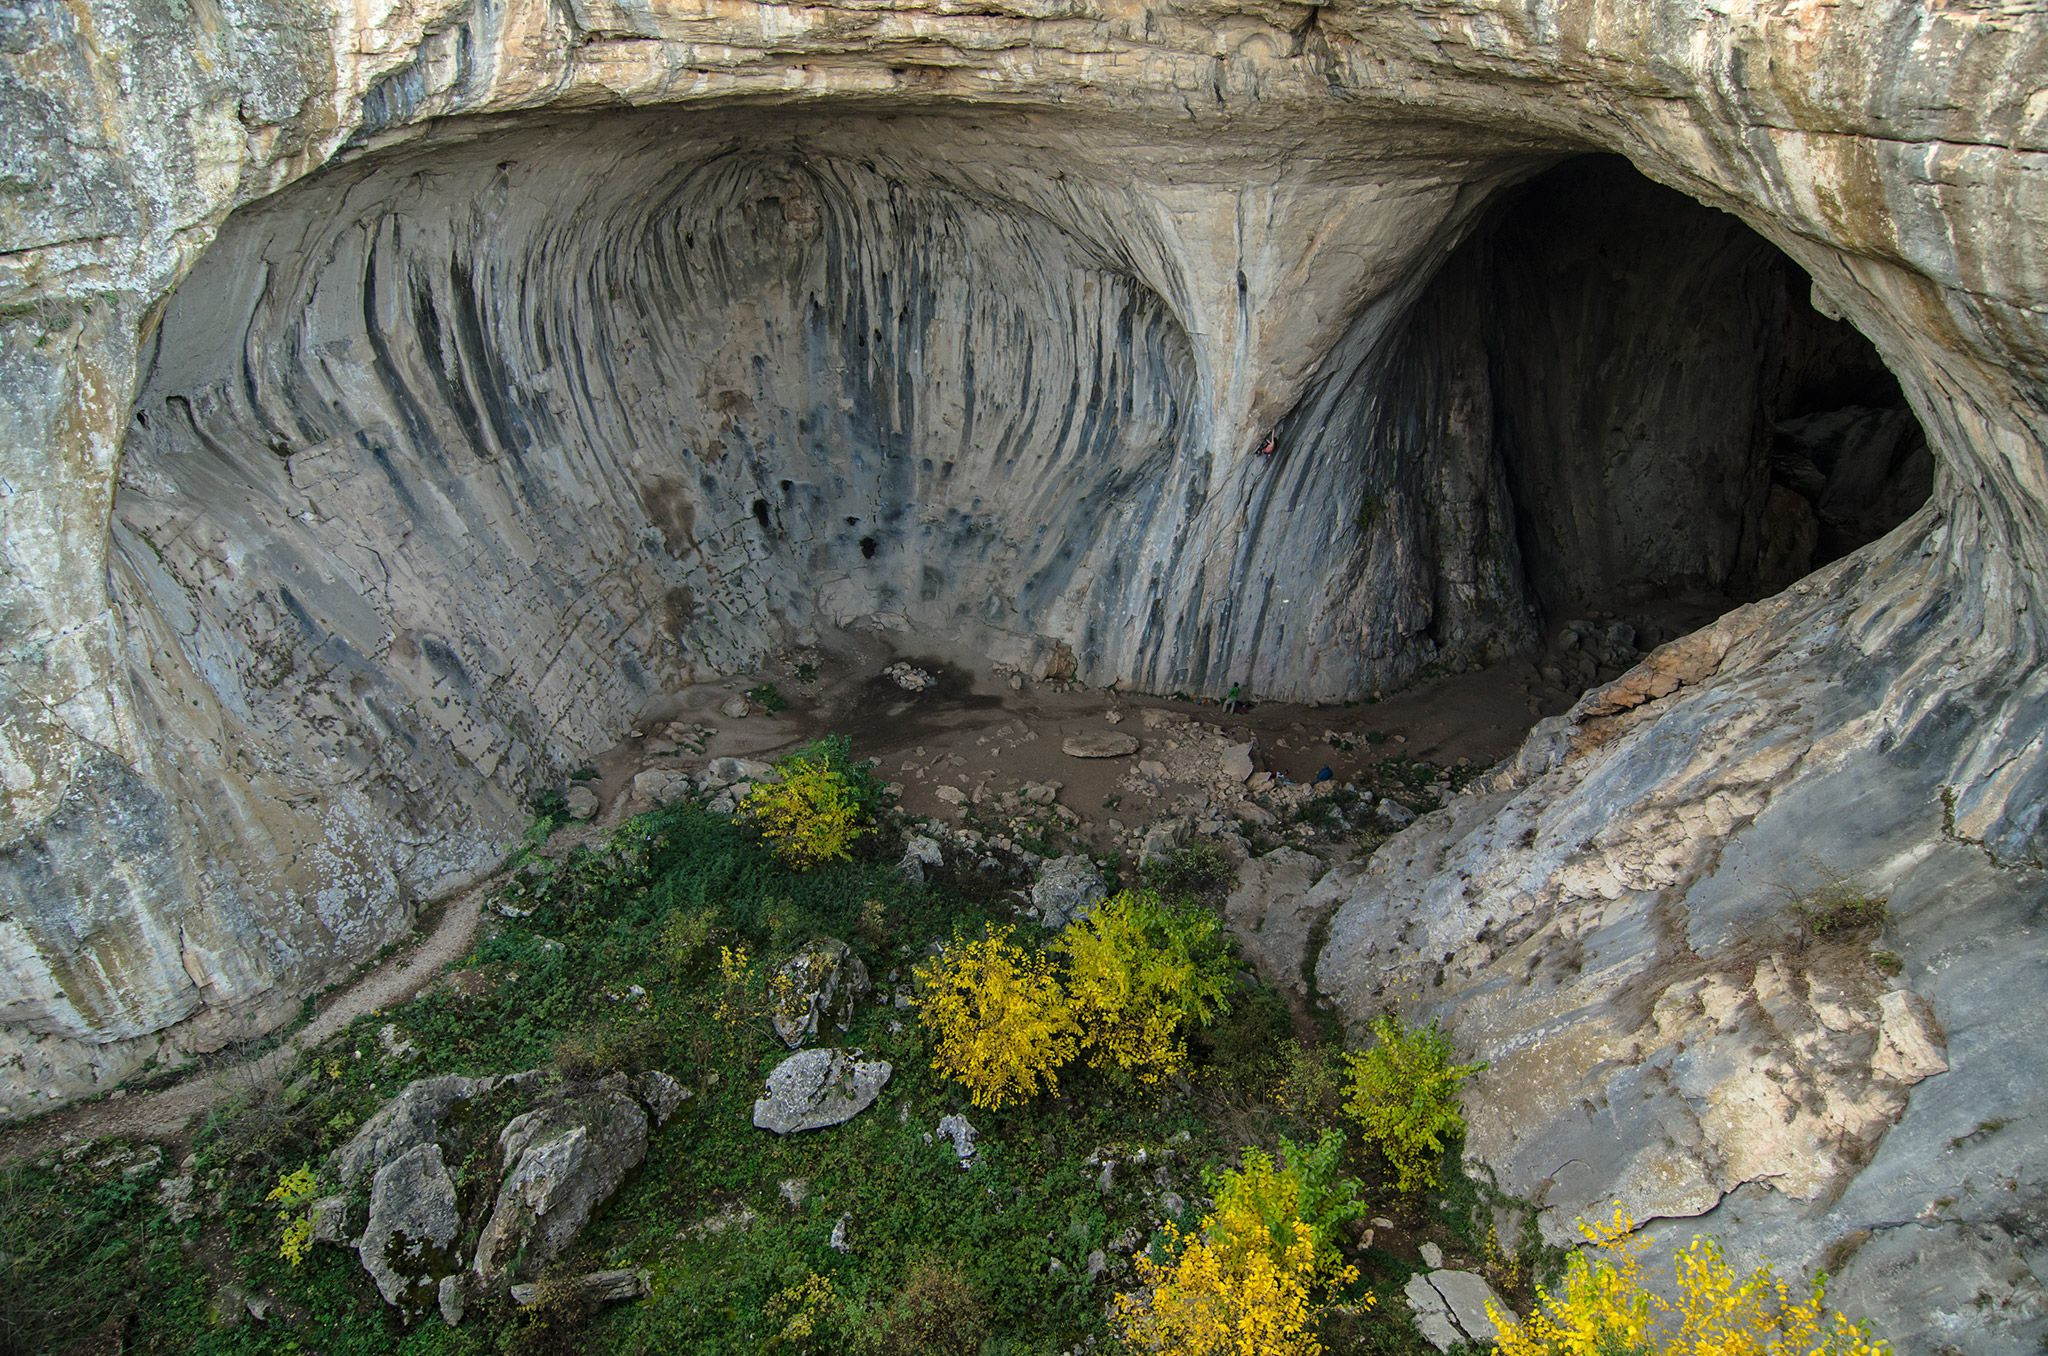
left=1343, top=1016, right=1487, bottom=1194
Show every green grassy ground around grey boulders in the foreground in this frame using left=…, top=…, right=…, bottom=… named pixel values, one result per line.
left=0, top=753, right=1540, bottom=1356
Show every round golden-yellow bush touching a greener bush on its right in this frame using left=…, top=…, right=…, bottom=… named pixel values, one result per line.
left=913, top=928, right=1075, bottom=1110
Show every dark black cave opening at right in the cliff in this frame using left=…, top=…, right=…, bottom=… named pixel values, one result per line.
left=1411, top=156, right=1933, bottom=668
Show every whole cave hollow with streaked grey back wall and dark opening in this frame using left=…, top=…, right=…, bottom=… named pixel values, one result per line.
left=99, top=115, right=1931, bottom=1026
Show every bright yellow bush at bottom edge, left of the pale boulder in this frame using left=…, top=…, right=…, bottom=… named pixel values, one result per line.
left=1116, top=1149, right=1370, bottom=1356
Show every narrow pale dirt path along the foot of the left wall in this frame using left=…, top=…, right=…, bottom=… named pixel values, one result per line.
left=0, top=877, right=498, bottom=1163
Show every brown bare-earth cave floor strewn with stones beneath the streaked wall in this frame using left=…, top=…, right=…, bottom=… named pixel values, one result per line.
left=590, top=633, right=1585, bottom=852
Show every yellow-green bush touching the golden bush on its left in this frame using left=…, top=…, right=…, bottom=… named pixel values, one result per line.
left=1053, top=889, right=1231, bottom=1084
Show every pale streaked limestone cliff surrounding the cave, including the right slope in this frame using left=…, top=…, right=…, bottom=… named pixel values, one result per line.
left=0, top=0, right=2048, bottom=1350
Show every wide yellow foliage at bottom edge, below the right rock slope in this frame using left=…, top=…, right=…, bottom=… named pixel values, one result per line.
left=1487, top=1206, right=1890, bottom=1356
